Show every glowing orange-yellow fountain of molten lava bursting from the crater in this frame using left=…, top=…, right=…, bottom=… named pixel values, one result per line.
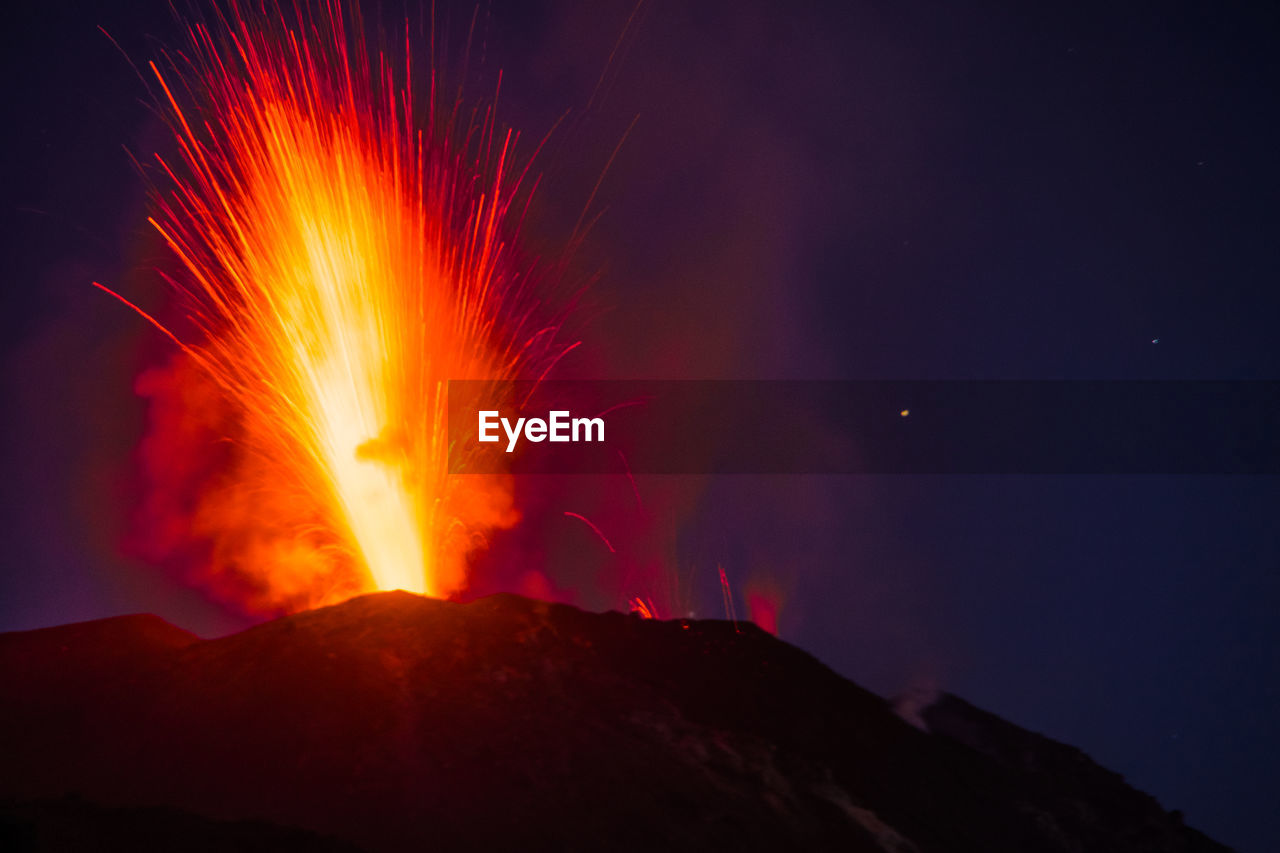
left=111, top=4, right=565, bottom=610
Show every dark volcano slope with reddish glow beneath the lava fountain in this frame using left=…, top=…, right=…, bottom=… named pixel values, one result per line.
left=0, top=592, right=1226, bottom=853
